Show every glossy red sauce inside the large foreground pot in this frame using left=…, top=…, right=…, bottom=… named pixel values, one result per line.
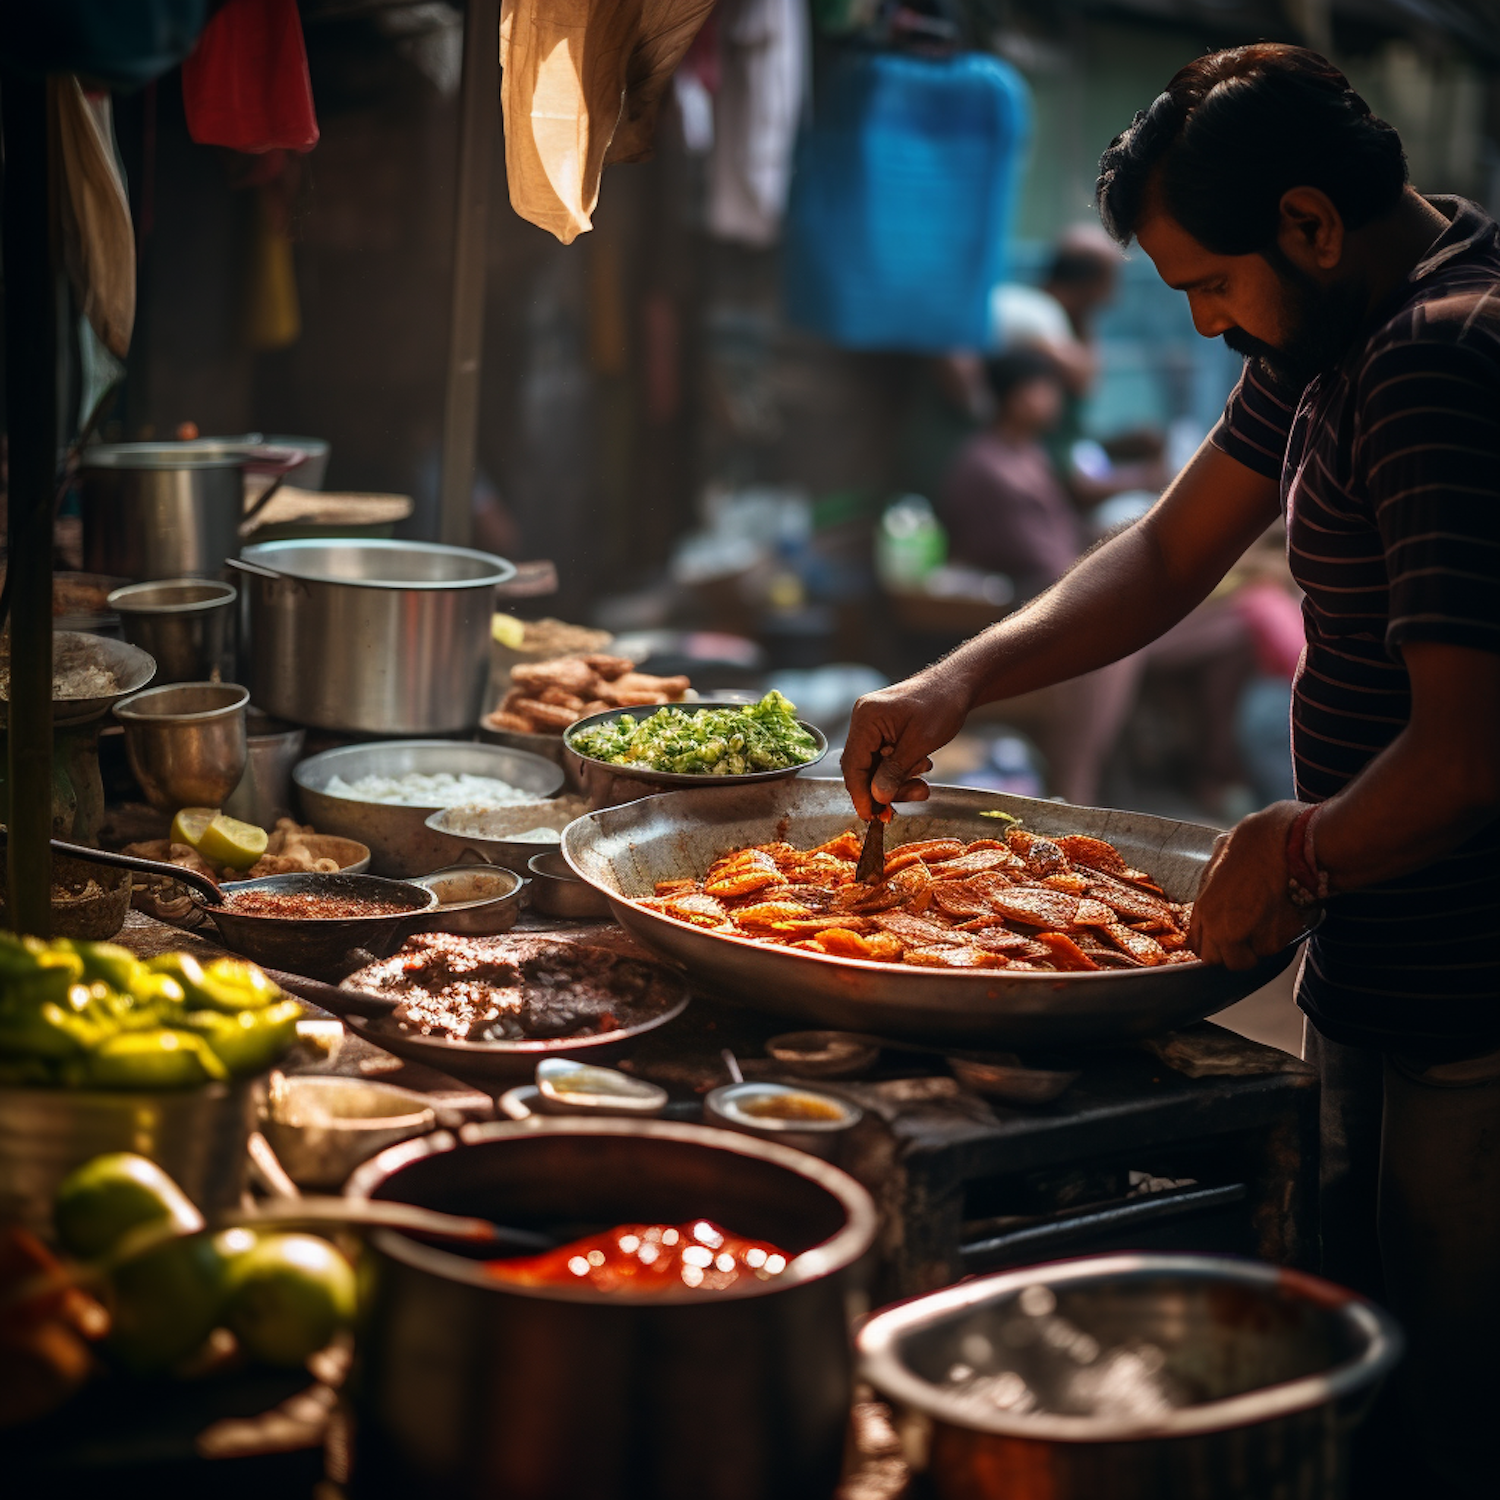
left=485, top=1220, right=792, bottom=1296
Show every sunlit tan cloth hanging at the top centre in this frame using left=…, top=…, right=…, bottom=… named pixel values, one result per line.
left=500, top=0, right=714, bottom=245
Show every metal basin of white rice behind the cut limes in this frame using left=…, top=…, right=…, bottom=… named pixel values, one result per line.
left=293, top=740, right=563, bottom=876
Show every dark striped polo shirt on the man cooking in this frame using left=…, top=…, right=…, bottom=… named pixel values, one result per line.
left=1212, top=198, right=1500, bottom=1056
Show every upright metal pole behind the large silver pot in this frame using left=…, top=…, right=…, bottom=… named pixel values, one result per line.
left=438, top=0, right=500, bottom=546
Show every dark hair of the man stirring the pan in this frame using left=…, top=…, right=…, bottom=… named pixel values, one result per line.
left=1097, top=42, right=1407, bottom=255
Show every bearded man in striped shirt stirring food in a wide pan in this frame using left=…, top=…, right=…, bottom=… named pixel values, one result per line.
left=843, top=44, right=1500, bottom=1497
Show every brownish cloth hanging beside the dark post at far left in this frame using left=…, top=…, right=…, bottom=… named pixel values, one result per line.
left=47, top=77, right=135, bottom=360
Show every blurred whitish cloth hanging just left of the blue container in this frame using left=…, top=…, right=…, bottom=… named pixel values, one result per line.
left=708, top=0, right=810, bottom=246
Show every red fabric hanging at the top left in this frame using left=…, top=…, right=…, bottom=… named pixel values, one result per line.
left=183, top=0, right=318, bottom=153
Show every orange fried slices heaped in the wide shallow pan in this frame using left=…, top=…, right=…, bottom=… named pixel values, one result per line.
left=638, top=827, right=1197, bottom=974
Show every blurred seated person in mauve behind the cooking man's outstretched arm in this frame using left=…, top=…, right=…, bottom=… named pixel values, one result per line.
left=936, top=345, right=1251, bottom=807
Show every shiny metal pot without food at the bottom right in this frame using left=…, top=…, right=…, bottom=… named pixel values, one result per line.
left=858, top=1254, right=1401, bottom=1500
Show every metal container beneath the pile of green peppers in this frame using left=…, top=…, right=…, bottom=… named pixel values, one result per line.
left=0, top=1079, right=260, bottom=1241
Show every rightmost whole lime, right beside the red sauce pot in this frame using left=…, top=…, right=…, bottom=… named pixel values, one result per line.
left=224, top=1235, right=354, bottom=1368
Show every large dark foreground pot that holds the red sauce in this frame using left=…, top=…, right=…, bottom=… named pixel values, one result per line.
left=348, top=1118, right=876, bottom=1500
